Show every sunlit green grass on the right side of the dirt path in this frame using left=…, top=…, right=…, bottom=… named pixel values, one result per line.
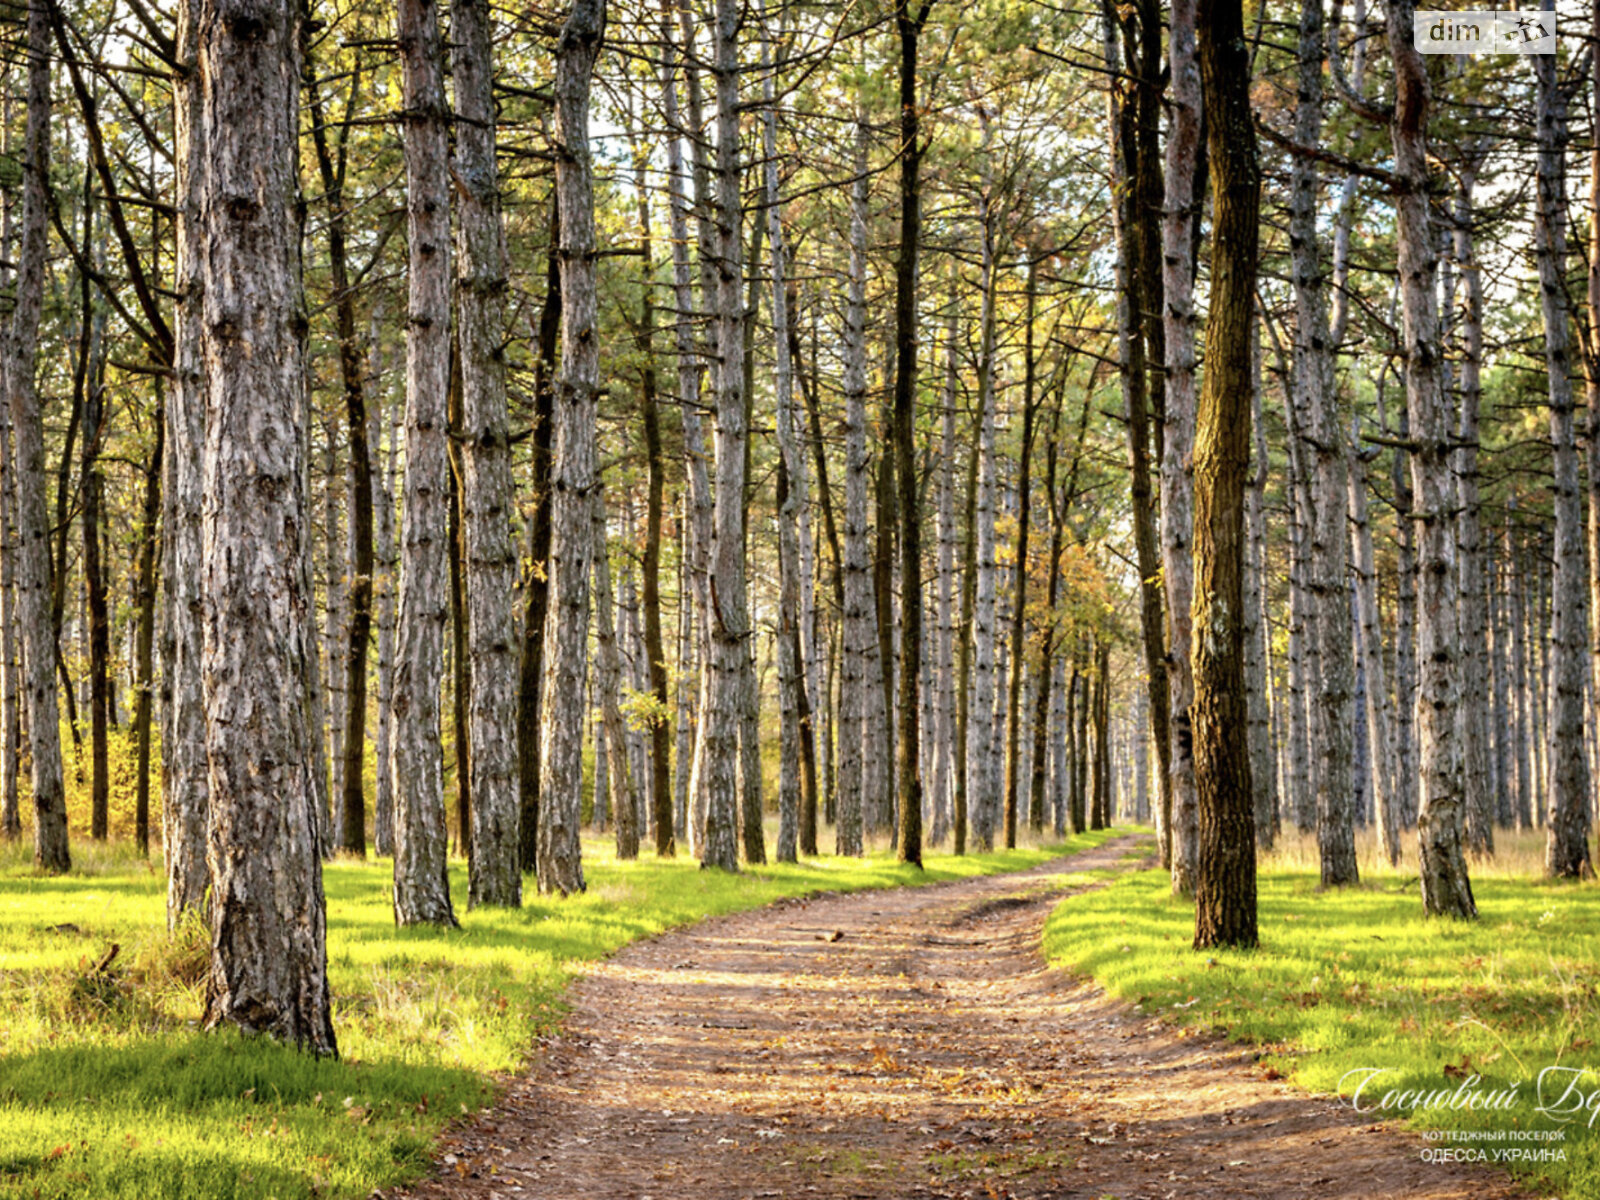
left=1045, top=848, right=1600, bottom=1197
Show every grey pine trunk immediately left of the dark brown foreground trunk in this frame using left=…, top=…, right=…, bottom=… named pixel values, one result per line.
left=1160, top=0, right=1203, bottom=896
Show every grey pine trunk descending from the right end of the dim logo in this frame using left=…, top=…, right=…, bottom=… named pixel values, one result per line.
left=1529, top=23, right=1590, bottom=878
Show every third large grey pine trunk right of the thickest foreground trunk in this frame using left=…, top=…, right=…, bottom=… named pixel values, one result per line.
left=539, top=0, right=606, bottom=896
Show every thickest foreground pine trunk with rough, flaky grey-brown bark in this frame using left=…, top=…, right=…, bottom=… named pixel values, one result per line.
left=198, top=0, right=338, bottom=1054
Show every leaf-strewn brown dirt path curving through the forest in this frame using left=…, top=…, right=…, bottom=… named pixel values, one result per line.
left=397, top=837, right=1522, bottom=1200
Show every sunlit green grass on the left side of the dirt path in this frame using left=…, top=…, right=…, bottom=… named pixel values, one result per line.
left=0, top=834, right=1109, bottom=1200
